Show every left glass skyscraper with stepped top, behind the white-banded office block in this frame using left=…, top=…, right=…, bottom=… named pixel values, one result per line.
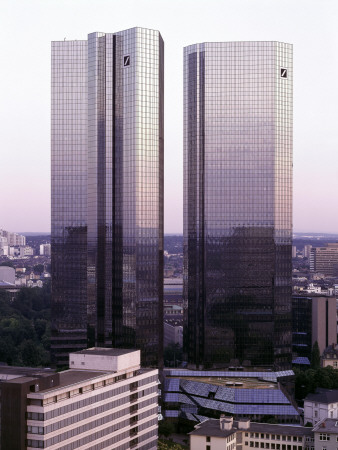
left=51, top=28, right=163, bottom=365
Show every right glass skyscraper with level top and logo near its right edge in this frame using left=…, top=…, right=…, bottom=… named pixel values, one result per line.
left=184, top=42, right=293, bottom=368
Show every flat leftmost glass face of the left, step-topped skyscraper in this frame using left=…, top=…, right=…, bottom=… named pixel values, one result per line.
left=51, top=41, right=88, bottom=365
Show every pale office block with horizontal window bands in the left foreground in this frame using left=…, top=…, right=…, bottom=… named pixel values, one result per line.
left=1, top=348, right=158, bottom=450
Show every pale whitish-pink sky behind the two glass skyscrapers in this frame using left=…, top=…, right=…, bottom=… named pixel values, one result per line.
left=0, top=0, right=338, bottom=233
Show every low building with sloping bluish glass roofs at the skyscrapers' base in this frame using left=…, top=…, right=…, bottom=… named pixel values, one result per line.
left=163, top=369, right=300, bottom=423
